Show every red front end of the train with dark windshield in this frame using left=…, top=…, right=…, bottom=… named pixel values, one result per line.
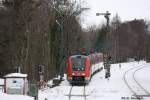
left=67, top=55, right=91, bottom=84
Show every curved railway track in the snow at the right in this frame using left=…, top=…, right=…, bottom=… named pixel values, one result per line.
left=123, top=65, right=150, bottom=100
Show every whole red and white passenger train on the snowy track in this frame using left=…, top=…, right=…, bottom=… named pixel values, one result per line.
left=67, top=53, right=103, bottom=84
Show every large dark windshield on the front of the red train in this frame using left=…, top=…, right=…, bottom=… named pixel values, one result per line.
left=72, top=56, right=86, bottom=71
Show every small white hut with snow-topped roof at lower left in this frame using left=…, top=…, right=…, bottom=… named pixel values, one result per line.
left=4, top=73, right=28, bottom=95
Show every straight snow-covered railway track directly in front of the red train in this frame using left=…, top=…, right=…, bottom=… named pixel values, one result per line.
left=68, top=85, right=87, bottom=100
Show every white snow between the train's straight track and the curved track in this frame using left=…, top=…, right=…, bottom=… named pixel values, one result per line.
left=89, top=62, right=148, bottom=100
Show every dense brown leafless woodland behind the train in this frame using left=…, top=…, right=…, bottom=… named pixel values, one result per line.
left=0, top=0, right=150, bottom=80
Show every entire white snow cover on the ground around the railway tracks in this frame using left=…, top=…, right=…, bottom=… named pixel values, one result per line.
left=0, top=61, right=150, bottom=100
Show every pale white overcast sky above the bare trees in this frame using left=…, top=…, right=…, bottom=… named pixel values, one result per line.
left=79, top=0, right=150, bottom=27
